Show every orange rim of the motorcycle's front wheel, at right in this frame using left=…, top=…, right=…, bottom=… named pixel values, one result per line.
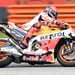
left=59, top=45, right=75, bottom=63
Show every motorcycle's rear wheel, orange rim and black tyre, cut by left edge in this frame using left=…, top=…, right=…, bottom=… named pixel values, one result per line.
left=0, top=52, right=12, bottom=68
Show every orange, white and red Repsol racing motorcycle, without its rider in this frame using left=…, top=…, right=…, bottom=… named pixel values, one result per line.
left=0, top=11, right=75, bottom=67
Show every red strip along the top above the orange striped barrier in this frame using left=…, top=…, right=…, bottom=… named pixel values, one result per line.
left=0, top=0, right=75, bottom=6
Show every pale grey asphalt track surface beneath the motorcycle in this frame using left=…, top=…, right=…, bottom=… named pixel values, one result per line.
left=0, top=63, right=75, bottom=75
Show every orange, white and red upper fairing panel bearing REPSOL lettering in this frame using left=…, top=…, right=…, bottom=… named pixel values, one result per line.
left=29, top=26, right=71, bottom=51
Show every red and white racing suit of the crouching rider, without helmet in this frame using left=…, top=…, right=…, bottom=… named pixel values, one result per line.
left=22, top=13, right=68, bottom=47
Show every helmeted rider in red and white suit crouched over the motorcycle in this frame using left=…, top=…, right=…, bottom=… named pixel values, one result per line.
left=22, top=6, right=68, bottom=47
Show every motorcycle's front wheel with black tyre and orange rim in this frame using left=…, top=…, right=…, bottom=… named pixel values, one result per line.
left=57, top=44, right=75, bottom=67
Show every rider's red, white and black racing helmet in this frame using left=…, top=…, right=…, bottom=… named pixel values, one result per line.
left=44, top=6, right=58, bottom=19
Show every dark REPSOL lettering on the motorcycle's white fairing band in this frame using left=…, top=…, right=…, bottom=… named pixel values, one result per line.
left=40, top=32, right=65, bottom=40
